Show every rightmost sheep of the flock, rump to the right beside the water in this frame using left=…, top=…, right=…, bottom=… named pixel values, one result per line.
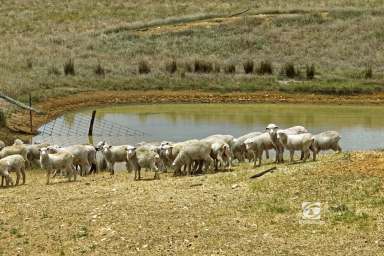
left=311, top=131, right=341, bottom=161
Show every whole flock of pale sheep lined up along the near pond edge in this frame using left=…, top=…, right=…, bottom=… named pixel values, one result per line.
left=0, top=124, right=341, bottom=186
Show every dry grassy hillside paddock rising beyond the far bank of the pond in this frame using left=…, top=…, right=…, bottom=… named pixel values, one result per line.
left=0, top=0, right=384, bottom=99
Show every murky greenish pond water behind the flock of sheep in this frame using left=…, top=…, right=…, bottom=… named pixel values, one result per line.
left=34, top=104, right=384, bottom=150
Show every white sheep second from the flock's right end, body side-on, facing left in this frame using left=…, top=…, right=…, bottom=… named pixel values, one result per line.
left=279, top=132, right=314, bottom=162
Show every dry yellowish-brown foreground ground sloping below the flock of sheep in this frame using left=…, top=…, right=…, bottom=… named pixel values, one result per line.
left=0, top=152, right=384, bottom=255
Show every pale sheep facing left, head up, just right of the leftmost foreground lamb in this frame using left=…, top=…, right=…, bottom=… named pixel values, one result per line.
left=40, top=148, right=77, bottom=185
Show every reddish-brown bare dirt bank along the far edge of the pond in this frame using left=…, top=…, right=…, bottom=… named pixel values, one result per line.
left=8, top=91, right=384, bottom=133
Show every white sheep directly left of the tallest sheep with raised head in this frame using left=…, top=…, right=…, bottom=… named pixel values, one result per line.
left=244, top=132, right=278, bottom=167
